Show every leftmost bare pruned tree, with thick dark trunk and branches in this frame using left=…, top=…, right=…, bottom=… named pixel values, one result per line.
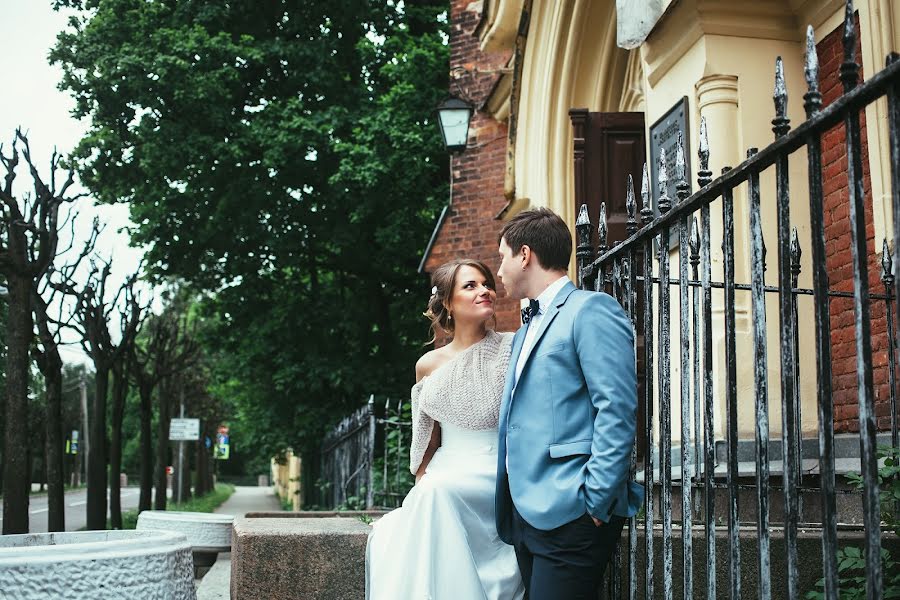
left=0, top=129, right=84, bottom=534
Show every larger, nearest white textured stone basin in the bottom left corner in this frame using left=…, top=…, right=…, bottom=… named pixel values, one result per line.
left=0, top=530, right=197, bottom=600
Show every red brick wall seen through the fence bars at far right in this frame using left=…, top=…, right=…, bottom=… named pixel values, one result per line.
left=810, top=16, right=890, bottom=432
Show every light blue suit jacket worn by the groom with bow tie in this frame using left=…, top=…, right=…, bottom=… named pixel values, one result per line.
left=496, top=282, right=644, bottom=543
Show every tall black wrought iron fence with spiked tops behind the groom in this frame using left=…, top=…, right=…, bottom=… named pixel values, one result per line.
left=576, top=2, right=900, bottom=599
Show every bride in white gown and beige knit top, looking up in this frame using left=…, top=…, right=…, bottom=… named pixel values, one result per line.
left=366, top=260, right=525, bottom=600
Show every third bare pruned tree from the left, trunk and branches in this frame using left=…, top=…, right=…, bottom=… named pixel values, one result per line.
left=75, top=260, right=138, bottom=529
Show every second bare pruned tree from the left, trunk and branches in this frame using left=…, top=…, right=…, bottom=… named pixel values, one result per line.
left=32, top=213, right=100, bottom=531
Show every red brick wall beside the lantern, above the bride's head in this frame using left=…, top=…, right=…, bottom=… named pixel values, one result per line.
left=425, top=0, right=520, bottom=344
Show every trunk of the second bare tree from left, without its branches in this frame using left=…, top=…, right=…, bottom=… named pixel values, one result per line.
left=43, top=354, right=66, bottom=531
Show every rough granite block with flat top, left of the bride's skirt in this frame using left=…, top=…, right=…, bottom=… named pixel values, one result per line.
left=231, top=517, right=371, bottom=600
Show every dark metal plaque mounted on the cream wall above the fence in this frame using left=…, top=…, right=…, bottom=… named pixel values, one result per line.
left=647, top=96, right=691, bottom=245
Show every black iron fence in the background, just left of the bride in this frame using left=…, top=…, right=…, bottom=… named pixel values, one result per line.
left=319, top=395, right=413, bottom=509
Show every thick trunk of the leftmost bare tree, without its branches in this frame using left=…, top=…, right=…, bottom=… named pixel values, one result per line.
left=3, top=277, right=34, bottom=535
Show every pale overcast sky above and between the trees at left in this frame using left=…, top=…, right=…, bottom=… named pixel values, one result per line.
left=0, top=0, right=146, bottom=362
